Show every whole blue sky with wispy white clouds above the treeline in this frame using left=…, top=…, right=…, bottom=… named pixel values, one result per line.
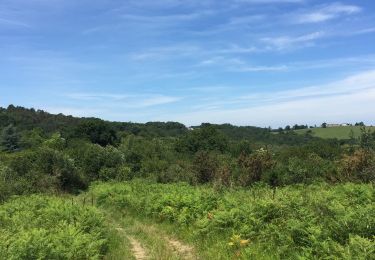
left=0, top=0, right=375, bottom=127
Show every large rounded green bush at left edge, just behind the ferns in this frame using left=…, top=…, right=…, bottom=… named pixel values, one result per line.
left=0, top=147, right=85, bottom=199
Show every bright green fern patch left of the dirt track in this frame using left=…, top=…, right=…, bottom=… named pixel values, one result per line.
left=0, top=195, right=108, bottom=260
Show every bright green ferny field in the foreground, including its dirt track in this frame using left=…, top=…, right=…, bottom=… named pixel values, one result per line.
left=0, top=180, right=375, bottom=260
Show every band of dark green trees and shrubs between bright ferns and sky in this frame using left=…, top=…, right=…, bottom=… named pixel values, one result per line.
left=0, top=105, right=375, bottom=200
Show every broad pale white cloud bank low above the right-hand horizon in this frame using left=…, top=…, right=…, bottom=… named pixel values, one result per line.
left=158, top=70, right=375, bottom=127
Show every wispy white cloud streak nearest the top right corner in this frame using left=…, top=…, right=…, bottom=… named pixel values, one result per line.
left=290, top=3, right=362, bottom=24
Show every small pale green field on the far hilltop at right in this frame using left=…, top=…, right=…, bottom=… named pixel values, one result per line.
left=295, top=126, right=375, bottom=139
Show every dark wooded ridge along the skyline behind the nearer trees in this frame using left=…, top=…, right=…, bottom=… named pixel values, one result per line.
left=0, top=105, right=318, bottom=145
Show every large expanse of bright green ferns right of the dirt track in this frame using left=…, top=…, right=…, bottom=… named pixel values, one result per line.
left=90, top=181, right=375, bottom=259
